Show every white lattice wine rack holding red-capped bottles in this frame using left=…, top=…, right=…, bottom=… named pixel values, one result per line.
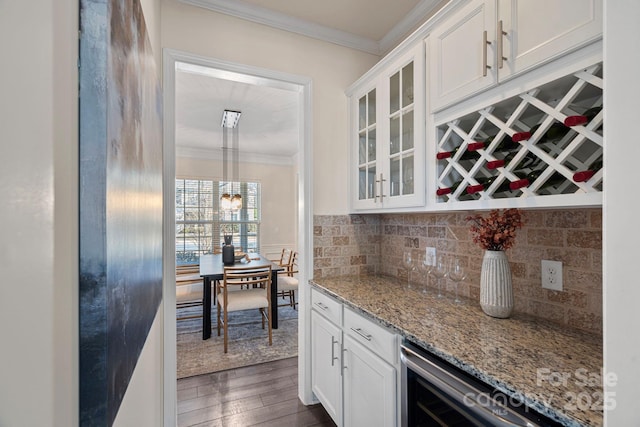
left=435, top=63, right=603, bottom=204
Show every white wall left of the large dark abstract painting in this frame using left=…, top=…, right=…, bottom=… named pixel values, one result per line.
left=0, top=0, right=78, bottom=426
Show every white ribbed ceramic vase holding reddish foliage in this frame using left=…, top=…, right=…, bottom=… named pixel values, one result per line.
left=480, top=251, right=513, bottom=319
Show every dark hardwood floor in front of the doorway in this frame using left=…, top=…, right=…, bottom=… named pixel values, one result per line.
left=178, top=357, right=335, bottom=427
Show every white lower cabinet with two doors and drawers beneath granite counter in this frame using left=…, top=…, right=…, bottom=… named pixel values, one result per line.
left=311, top=289, right=398, bottom=427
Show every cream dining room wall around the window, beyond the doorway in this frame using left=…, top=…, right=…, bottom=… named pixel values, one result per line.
left=176, top=157, right=298, bottom=248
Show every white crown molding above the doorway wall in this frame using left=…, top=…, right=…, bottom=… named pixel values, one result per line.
left=178, top=0, right=380, bottom=55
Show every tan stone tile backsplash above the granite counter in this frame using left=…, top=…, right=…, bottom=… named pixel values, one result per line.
left=314, top=208, right=602, bottom=334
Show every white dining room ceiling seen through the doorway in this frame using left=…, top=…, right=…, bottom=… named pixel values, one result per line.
left=175, top=64, right=298, bottom=165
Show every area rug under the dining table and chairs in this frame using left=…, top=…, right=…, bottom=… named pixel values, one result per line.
left=177, top=307, right=298, bottom=379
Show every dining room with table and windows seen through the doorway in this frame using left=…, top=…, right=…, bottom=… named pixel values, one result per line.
left=175, top=57, right=300, bottom=379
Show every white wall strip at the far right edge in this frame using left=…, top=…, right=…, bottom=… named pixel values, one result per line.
left=603, top=0, right=640, bottom=426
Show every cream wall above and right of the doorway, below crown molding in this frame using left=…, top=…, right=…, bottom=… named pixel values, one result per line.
left=162, top=0, right=379, bottom=214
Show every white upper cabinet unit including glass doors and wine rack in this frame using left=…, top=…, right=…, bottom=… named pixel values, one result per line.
left=346, top=0, right=604, bottom=213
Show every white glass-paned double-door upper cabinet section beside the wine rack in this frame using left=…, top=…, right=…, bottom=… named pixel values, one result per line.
left=350, top=43, right=425, bottom=210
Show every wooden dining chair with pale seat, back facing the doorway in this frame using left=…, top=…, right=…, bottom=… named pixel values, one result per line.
left=217, top=265, right=272, bottom=353
